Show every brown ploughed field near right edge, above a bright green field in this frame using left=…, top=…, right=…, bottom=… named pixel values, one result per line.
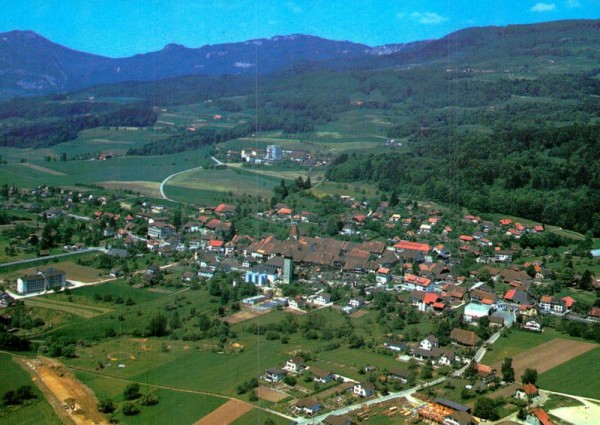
left=493, top=338, right=598, bottom=380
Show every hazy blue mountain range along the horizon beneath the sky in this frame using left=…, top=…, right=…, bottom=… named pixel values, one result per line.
left=0, top=20, right=600, bottom=98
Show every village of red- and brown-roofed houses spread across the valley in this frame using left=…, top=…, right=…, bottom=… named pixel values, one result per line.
left=2, top=181, right=600, bottom=425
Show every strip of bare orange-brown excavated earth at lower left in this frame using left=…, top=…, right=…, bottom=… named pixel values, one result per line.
left=19, top=357, right=108, bottom=425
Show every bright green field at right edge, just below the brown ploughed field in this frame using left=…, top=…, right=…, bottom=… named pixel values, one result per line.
left=537, top=347, right=600, bottom=399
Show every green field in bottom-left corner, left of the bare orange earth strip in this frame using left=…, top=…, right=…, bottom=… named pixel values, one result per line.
left=0, top=353, right=61, bottom=425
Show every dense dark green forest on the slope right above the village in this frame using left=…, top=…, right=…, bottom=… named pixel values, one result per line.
left=326, top=122, right=600, bottom=236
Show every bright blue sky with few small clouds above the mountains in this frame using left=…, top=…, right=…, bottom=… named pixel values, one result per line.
left=0, top=0, right=600, bottom=57
